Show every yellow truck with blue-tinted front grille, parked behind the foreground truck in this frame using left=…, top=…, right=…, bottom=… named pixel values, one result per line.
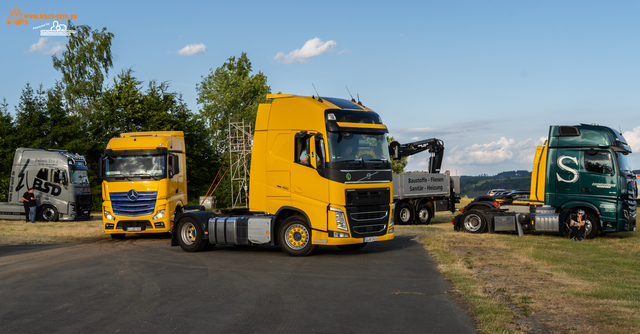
left=99, top=131, right=187, bottom=239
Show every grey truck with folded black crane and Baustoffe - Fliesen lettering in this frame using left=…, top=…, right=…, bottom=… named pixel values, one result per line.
left=389, top=138, right=460, bottom=224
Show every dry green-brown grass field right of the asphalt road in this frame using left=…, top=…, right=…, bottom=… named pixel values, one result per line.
left=398, top=200, right=640, bottom=333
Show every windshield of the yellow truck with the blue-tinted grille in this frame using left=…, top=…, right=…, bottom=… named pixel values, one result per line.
left=105, top=155, right=167, bottom=178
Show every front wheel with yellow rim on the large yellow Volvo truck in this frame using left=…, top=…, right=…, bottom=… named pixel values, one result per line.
left=279, top=216, right=318, bottom=256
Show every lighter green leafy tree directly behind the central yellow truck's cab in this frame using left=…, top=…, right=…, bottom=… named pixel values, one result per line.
left=196, top=52, right=271, bottom=156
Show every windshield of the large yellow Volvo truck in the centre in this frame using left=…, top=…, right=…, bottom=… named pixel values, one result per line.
left=328, top=132, right=389, bottom=162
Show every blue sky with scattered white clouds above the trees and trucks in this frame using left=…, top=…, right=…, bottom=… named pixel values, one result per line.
left=0, top=0, right=640, bottom=175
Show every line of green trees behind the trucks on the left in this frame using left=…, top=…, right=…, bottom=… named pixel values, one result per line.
left=0, top=22, right=270, bottom=211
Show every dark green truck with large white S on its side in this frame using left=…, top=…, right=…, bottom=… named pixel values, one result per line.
left=452, top=124, right=638, bottom=239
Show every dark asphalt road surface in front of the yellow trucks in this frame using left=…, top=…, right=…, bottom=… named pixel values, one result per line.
left=0, top=237, right=475, bottom=333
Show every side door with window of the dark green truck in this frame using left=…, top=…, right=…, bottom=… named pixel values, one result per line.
left=580, top=149, right=618, bottom=221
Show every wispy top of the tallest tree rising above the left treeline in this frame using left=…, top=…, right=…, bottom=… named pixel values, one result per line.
left=52, top=21, right=113, bottom=113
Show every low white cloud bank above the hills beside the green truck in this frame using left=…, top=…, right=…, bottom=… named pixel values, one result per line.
left=444, top=137, right=546, bottom=166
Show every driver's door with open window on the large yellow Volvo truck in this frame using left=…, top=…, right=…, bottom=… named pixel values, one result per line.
left=291, top=131, right=329, bottom=230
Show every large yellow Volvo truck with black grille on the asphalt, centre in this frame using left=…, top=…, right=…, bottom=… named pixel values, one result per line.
left=171, top=94, right=394, bottom=256
